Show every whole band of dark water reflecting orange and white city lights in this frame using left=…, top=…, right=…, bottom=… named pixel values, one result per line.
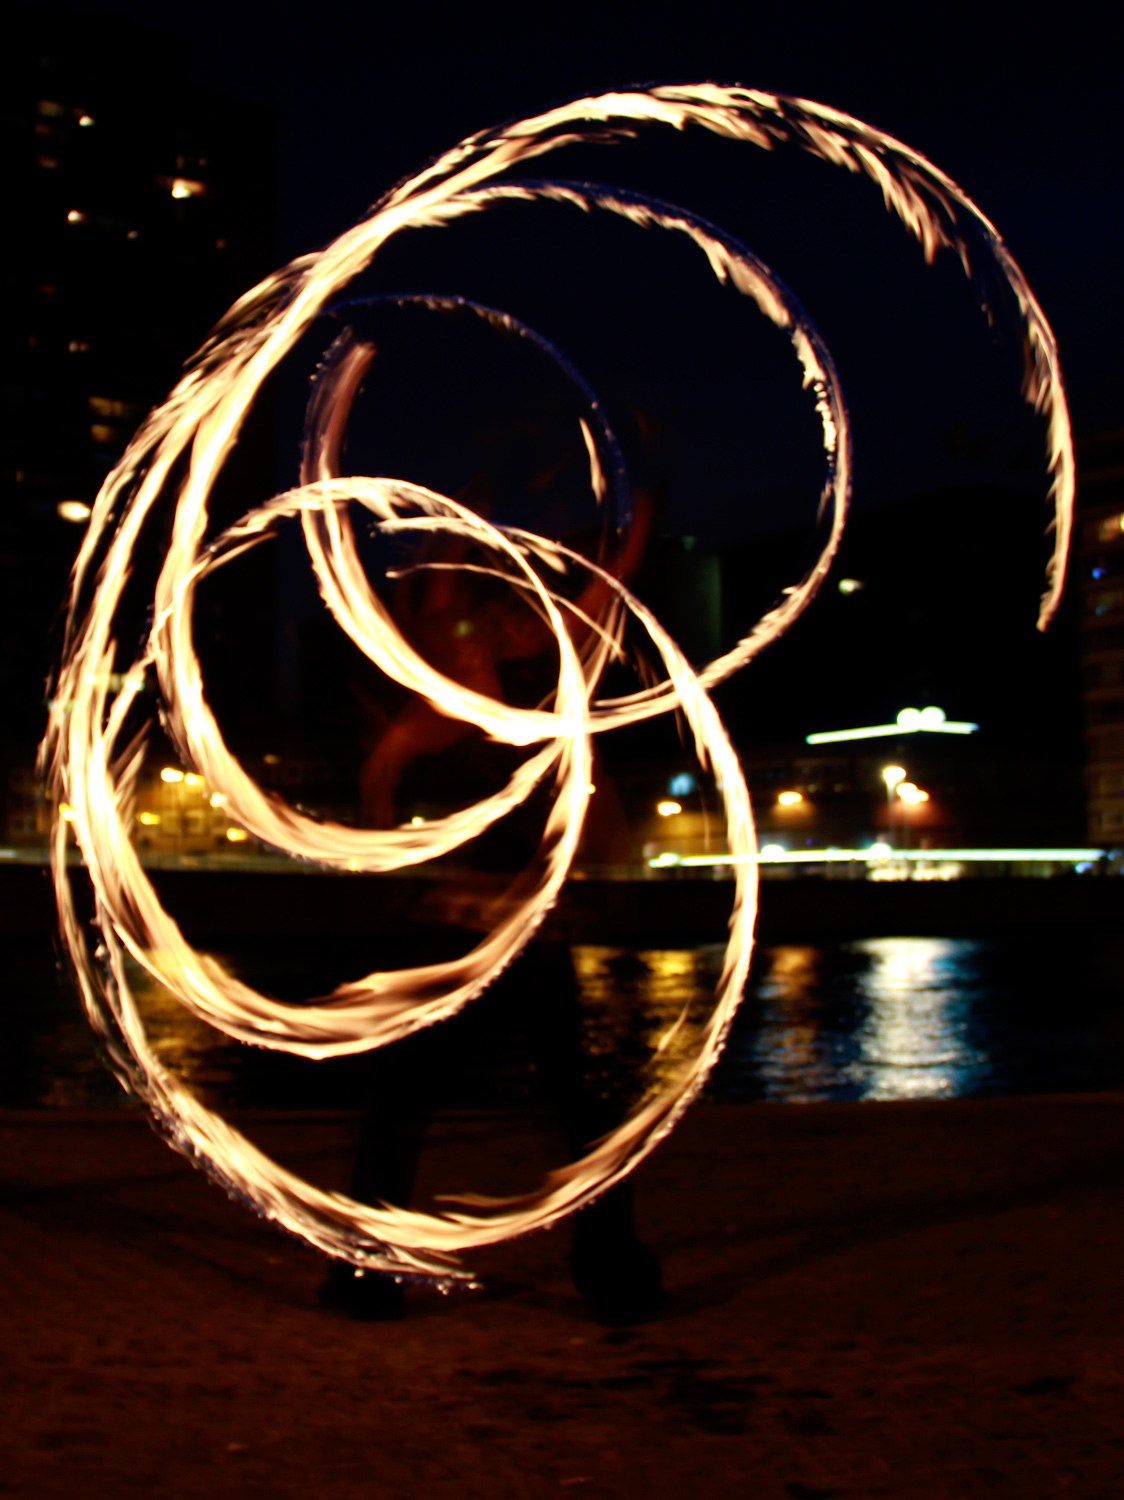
left=8, top=936, right=1124, bottom=1109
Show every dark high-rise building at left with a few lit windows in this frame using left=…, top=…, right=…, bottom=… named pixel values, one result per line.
left=0, top=5, right=276, bottom=824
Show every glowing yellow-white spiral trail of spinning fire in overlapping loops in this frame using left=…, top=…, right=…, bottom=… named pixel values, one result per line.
left=42, top=84, right=1074, bottom=1283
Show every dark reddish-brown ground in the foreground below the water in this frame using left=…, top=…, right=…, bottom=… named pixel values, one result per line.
left=0, top=1097, right=1124, bottom=1500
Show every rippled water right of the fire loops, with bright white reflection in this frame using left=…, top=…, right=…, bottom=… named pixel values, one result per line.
left=713, top=938, right=1124, bottom=1103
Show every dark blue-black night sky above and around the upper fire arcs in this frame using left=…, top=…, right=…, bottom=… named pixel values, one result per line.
left=59, top=0, right=1124, bottom=531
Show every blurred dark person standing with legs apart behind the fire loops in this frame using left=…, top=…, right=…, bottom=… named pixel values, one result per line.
left=321, top=450, right=662, bottom=1323
